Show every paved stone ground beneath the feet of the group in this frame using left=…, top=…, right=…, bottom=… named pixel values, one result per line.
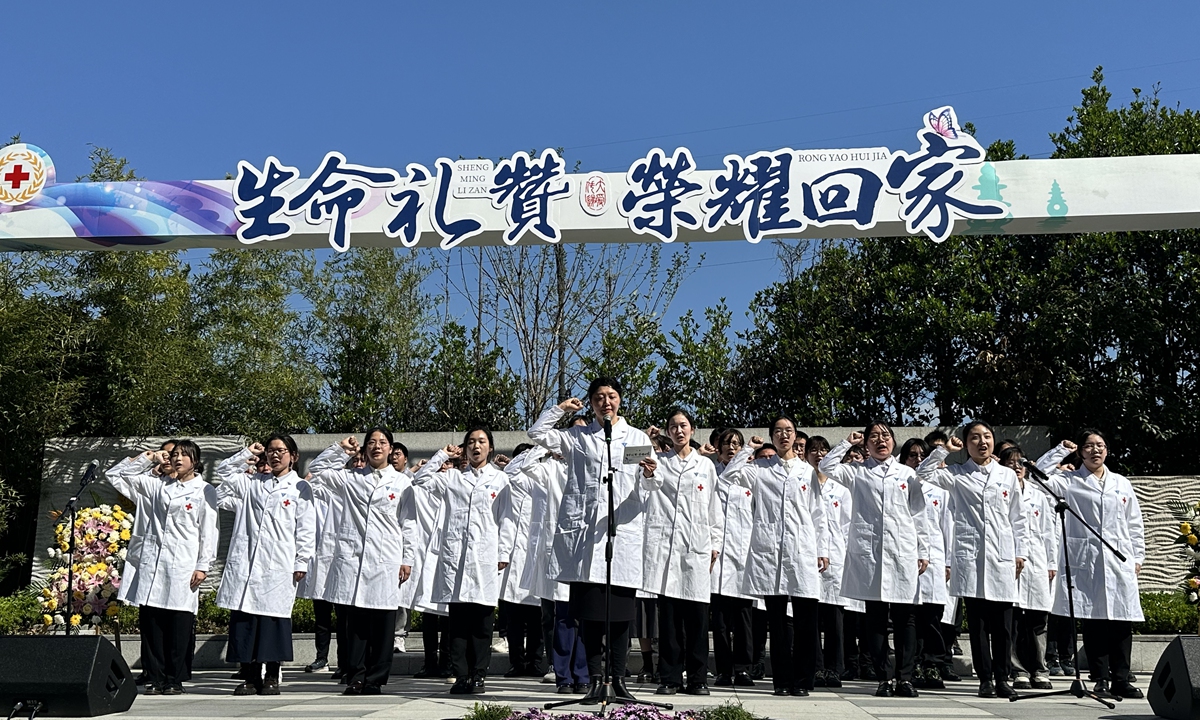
left=118, top=670, right=1153, bottom=720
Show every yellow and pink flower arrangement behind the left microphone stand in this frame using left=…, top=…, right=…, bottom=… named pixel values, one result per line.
left=41, top=504, right=133, bottom=629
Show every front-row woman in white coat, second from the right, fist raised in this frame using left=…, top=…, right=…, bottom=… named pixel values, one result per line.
left=917, top=420, right=1028, bottom=697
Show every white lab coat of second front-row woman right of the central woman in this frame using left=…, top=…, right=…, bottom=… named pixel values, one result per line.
left=721, top=446, right=829, bottom=600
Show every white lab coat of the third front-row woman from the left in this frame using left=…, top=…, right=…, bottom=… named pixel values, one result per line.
left=308, top=445, right=413, bottom=610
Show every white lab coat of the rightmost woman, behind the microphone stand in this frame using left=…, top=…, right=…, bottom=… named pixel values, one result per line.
left=1034, top=453, right=1146, bottom=623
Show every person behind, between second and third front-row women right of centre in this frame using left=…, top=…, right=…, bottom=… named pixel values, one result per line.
left=804, top=436, right=862, bottom=688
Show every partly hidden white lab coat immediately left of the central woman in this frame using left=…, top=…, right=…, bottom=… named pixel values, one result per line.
left=504, top=445, right=570, bottom=601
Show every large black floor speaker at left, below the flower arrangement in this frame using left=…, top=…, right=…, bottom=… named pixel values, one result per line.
left=0, top=635, right=138, bottom=718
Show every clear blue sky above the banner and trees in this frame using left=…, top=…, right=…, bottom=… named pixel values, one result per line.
left=0, top=0, right=1200, bottom=328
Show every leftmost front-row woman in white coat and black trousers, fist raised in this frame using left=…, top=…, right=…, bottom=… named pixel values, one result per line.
left=103, top=440, right=217, bottom=695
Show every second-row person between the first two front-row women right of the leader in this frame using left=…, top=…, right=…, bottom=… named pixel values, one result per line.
left=709, top=427, right=755, bottom=688
